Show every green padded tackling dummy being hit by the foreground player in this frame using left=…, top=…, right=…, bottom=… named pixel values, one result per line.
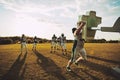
left=78, top=11, right=102, bottom=40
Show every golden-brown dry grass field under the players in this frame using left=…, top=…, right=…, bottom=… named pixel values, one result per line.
left=0, top=43, right=120, bottom=80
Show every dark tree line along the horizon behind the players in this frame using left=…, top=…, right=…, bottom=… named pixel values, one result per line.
left=0, top=36, right=119, bottom=44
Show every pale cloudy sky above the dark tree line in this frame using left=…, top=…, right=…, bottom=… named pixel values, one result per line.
left=0, top=0, right=120, bottom=40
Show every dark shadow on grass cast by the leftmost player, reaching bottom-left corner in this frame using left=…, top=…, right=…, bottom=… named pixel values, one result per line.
left=2, top=53, right=27, bottom=80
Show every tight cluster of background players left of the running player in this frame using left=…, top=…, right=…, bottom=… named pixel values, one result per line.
left=50, top=33, right=67, bottom=55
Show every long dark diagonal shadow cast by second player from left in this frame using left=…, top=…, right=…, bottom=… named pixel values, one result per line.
left=33, top=50, right=66, bottom=80
